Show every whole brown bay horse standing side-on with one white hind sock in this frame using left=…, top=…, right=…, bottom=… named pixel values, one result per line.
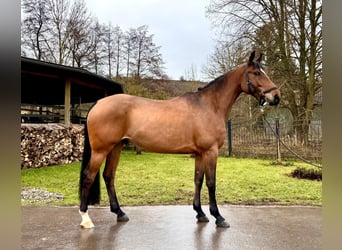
left=80, top=51, right=280, bottom=228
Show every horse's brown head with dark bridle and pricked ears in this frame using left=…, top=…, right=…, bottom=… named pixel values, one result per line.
left=241, top=51, right=280, bottom=106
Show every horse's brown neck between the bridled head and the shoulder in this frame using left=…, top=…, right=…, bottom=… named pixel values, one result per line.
left=203, top=70, right=241, bottom=117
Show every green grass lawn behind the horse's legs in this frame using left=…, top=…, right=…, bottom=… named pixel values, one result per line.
left=21, top=151, right=322, bottom=206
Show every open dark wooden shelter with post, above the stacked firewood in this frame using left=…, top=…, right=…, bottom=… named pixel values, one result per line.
left=21, top=57, right=123, bottom=124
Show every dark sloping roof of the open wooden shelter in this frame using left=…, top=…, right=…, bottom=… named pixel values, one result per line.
left=21, top=57, right=123, bottom=105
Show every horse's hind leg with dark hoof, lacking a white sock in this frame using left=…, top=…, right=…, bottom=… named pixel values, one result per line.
left=103, top=142, right=129, bottom=221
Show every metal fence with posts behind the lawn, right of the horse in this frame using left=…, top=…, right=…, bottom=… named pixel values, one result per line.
left=220, top=119, right=322, bottom=162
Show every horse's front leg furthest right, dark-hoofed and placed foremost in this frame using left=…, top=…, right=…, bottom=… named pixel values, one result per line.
left=205, top=150, right=230, bottom=228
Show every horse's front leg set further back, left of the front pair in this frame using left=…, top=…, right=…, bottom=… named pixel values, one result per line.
left=193, top=155, right=209, bottom=222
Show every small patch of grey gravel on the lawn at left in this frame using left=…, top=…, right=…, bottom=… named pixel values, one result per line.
left=21, top=188, right=64, bottom=203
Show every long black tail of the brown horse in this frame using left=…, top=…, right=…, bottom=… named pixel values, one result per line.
left=79, top=103, right=100, bottom=205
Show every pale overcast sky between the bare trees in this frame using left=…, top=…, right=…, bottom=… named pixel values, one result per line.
left=85, top=0, right=214, bottom=80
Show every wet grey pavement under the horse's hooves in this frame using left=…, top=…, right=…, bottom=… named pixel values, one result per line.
left=21, top=205, right=323, bottom=250
